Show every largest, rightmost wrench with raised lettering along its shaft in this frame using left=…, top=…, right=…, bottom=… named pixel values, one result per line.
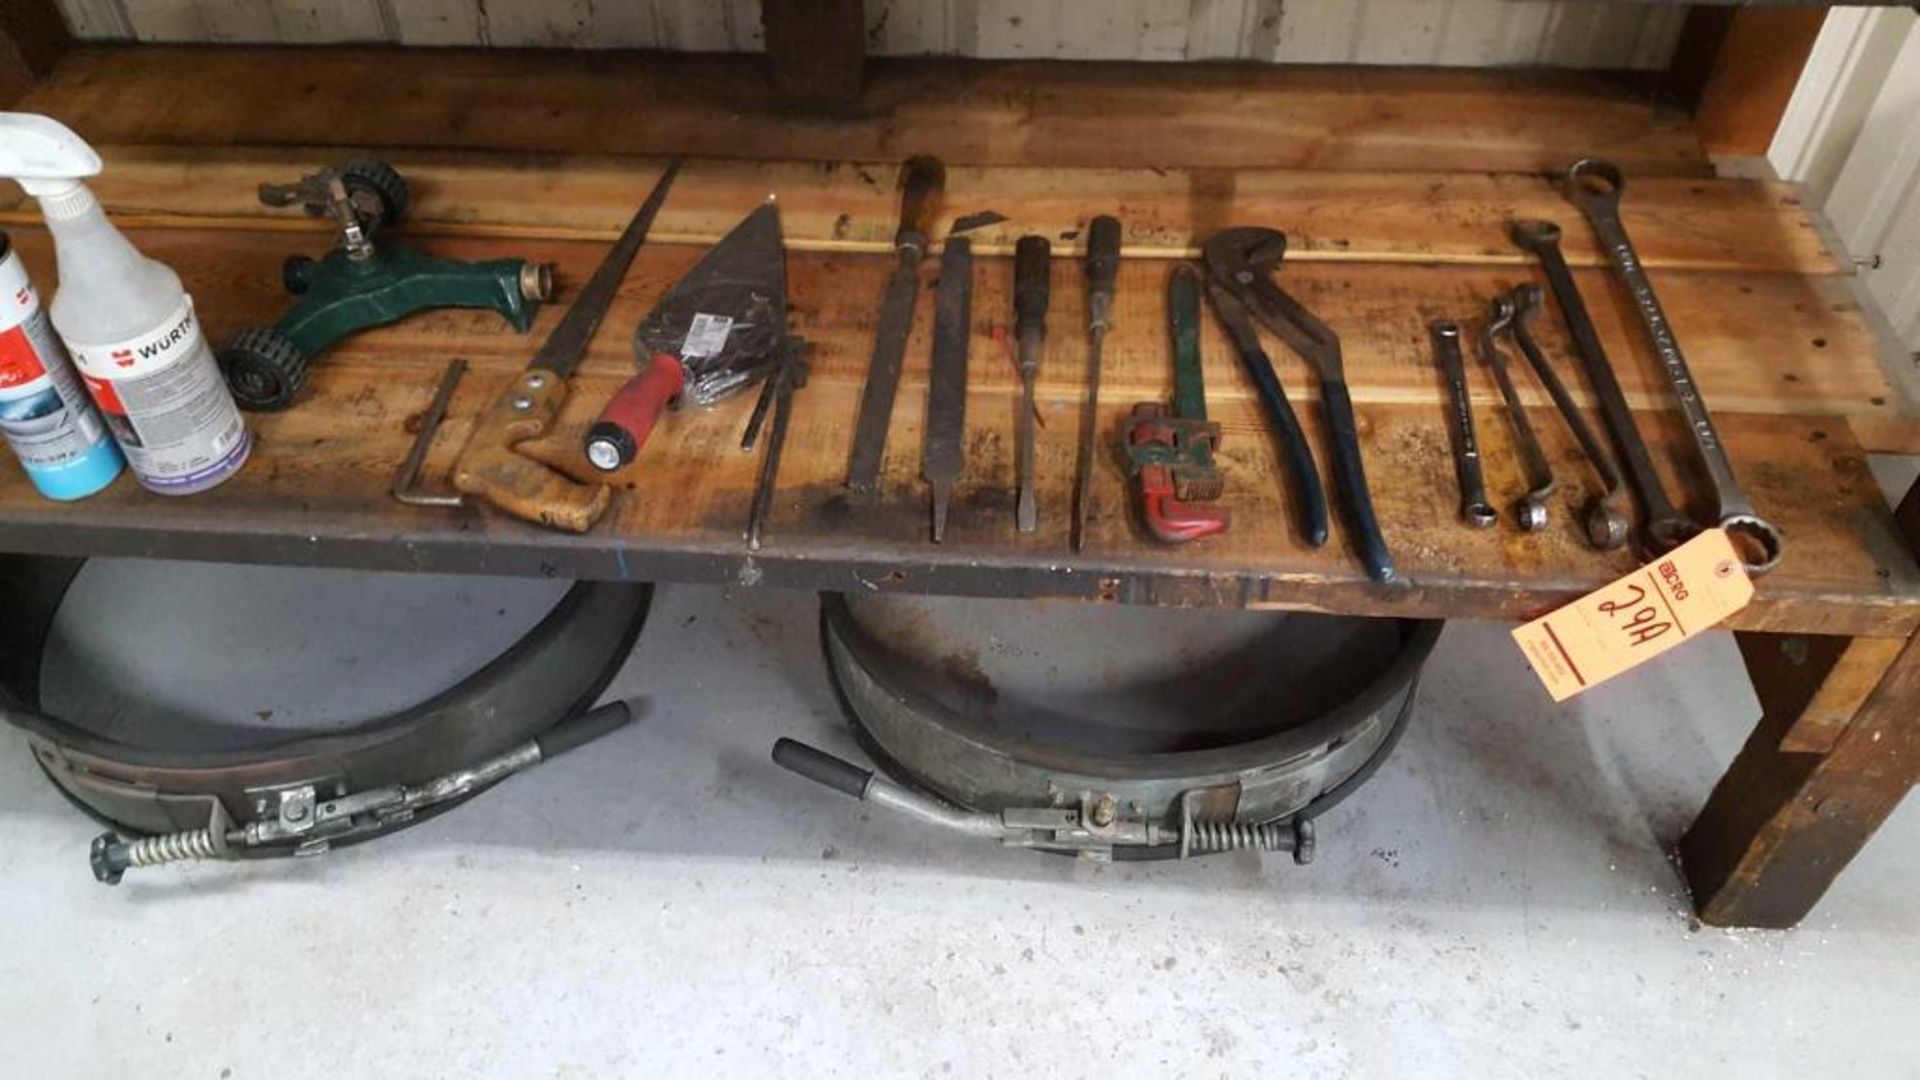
left=1567, top=158, right=1784, bottom=575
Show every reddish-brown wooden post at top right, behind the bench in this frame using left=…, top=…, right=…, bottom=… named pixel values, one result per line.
left=1678, top=8, right=1826, bottom=158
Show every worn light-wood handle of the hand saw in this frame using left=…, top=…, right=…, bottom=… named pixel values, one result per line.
left=453, top=367, right=612, bottom=532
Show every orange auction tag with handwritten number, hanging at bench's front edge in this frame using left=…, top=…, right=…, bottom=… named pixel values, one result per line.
left=1513, top=528, right=1753, bottom=701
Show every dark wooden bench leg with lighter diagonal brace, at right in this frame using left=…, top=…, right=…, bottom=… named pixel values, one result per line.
left=1680, top=474, right=1920, bottom=926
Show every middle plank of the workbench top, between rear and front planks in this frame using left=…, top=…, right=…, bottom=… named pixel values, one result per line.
left=0, top=229, right=1897, bottom=428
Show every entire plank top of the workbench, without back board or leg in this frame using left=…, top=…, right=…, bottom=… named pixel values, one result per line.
left=0, top=50, right=1920, bottom=636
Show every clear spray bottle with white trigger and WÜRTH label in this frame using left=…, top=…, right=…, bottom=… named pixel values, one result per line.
left=0, top=113, right=252, bottom=496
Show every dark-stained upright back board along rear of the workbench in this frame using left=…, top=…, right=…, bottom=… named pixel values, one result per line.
left=23, top=46, right=1709, bottom=177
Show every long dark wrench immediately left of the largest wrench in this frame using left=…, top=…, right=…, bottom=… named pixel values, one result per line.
left=1507, top=221, right=1699, bottom=555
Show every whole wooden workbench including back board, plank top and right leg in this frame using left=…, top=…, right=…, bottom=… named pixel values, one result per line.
left=0, top=48, right=1920, bottom=924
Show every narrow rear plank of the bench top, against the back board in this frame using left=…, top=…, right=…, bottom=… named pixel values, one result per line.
left=0, top=146, right=1841, bottom=275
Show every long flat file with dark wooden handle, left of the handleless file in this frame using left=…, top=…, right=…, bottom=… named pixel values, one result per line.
left=847, top=158, right=947, bottom=492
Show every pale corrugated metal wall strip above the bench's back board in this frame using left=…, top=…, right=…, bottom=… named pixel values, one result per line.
left=60, top=0, right=1686, bottom=69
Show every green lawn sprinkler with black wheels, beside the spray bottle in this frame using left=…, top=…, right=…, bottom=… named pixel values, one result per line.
left=219, top=161, right=553, bottom=411
